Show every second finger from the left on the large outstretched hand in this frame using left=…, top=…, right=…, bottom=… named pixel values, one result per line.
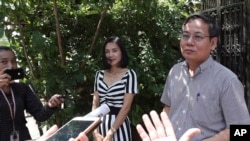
left=142, top=114, right=158, bottom=140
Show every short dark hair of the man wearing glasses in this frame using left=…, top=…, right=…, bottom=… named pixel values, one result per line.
left=182, top=13, right=220, bottom=39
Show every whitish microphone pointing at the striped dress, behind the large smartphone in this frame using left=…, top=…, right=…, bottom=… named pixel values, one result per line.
left=84, top=104, right=110, bottom=117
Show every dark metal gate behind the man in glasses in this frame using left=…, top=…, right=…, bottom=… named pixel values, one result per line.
left=202, top=0, right=250, bottom=110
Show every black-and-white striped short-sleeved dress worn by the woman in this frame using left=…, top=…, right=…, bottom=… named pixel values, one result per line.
left=94, top=69, right=138, bottom=141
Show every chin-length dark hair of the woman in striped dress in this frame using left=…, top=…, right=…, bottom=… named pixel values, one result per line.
left=102, top=36, right=129, bottom=69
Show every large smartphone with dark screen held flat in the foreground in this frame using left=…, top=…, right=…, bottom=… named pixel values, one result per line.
left=46, top=117, right=101, bottom=141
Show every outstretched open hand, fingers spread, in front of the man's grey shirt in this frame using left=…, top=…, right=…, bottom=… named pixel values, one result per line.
left=136, top=111, right=201, bottom=141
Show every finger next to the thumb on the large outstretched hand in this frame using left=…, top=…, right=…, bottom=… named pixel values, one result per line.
left=161, top=112, right=176, bottom=140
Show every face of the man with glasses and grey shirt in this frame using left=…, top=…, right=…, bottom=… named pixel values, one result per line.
left=180, top=19, right=218, bottom=65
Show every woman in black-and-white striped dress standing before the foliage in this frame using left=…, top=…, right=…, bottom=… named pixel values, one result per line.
left=92, top=36, right=138, bottom=141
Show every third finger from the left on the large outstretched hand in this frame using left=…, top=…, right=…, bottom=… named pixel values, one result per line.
left=150, top=110, right=166, bottom=138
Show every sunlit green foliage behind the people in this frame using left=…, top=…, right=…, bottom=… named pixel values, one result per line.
left=0, top=0, right=199, bottom=139
